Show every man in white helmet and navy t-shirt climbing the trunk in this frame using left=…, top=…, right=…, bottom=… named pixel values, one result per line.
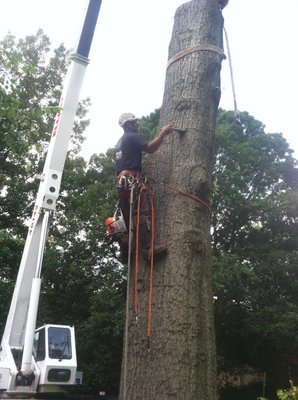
left=116, top=113, right=173, bottom=259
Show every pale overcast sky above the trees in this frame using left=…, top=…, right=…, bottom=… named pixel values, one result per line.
left=0, top=0, right=298, bottom=158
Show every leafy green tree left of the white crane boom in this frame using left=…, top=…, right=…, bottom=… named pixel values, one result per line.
left=0, top=31, right=70, bottom=331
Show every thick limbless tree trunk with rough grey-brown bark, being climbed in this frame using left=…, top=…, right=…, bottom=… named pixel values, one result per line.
left=120, top=0, right=223, bottom=400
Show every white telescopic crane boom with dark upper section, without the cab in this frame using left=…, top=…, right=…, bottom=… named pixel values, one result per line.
left=0, top=0, right=101, bottom=392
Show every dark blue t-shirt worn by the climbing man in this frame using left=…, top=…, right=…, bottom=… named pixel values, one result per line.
left=116, top=132, right=148, bottom=174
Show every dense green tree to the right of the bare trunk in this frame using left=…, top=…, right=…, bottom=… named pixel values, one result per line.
left=212, top=110, right=298, bottom=394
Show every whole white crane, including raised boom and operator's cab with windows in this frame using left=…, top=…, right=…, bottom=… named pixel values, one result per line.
left=0, top=0, right=101, bottom=398
